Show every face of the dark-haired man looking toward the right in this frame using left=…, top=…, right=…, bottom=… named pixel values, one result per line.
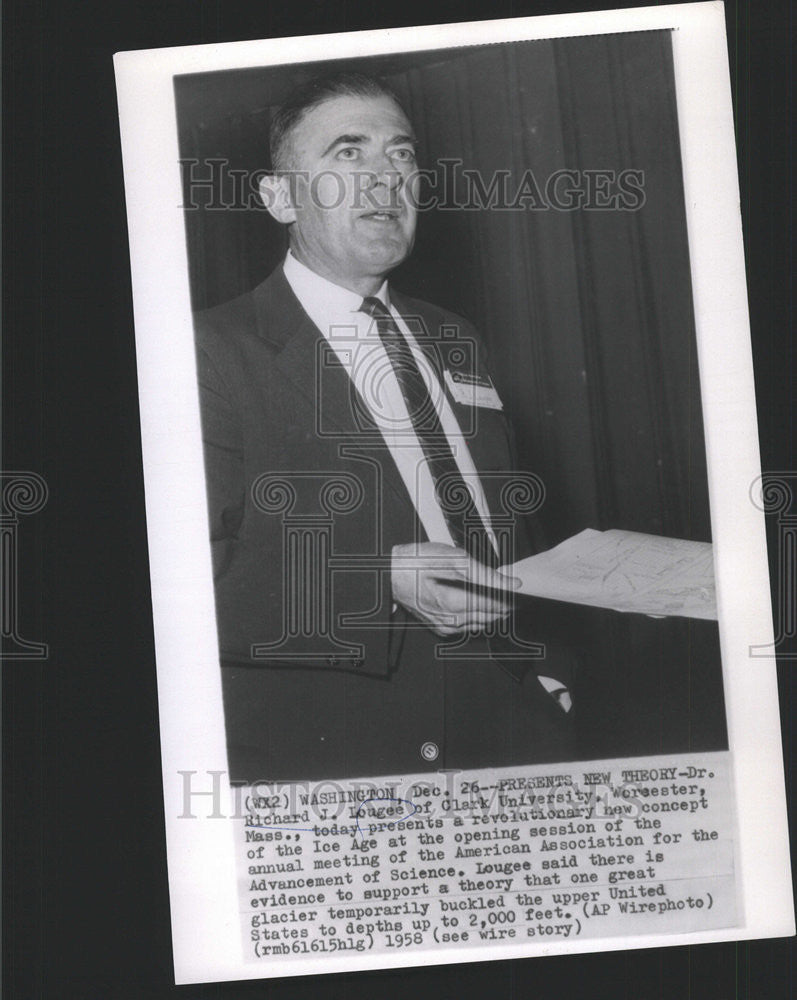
left=278, top=96, right=416, bottom=295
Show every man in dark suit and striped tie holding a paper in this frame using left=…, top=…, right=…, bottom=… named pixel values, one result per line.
left=196, top=74, right=574, bottom=781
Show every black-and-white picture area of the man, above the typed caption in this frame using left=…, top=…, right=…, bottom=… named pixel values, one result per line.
left=174, top=30, right=728, bottom=784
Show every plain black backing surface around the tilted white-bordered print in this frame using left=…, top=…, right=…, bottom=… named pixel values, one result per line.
left=1, top=0, right=795, bottom=1000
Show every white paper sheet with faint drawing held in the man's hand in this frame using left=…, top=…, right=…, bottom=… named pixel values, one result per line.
left=502, top=528, right=717, bottom=618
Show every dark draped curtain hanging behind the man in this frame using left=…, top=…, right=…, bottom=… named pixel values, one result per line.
left=175, top=32, right=726, bottom=757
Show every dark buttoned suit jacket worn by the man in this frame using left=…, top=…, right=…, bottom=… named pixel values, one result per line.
left=195, top=267, right=572, bottom=781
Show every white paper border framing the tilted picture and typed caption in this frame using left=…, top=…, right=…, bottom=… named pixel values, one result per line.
left=115, top=2, right=794, bottom=983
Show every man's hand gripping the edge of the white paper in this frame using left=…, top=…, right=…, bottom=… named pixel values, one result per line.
left=391, top=542, right=520, bottom=636
